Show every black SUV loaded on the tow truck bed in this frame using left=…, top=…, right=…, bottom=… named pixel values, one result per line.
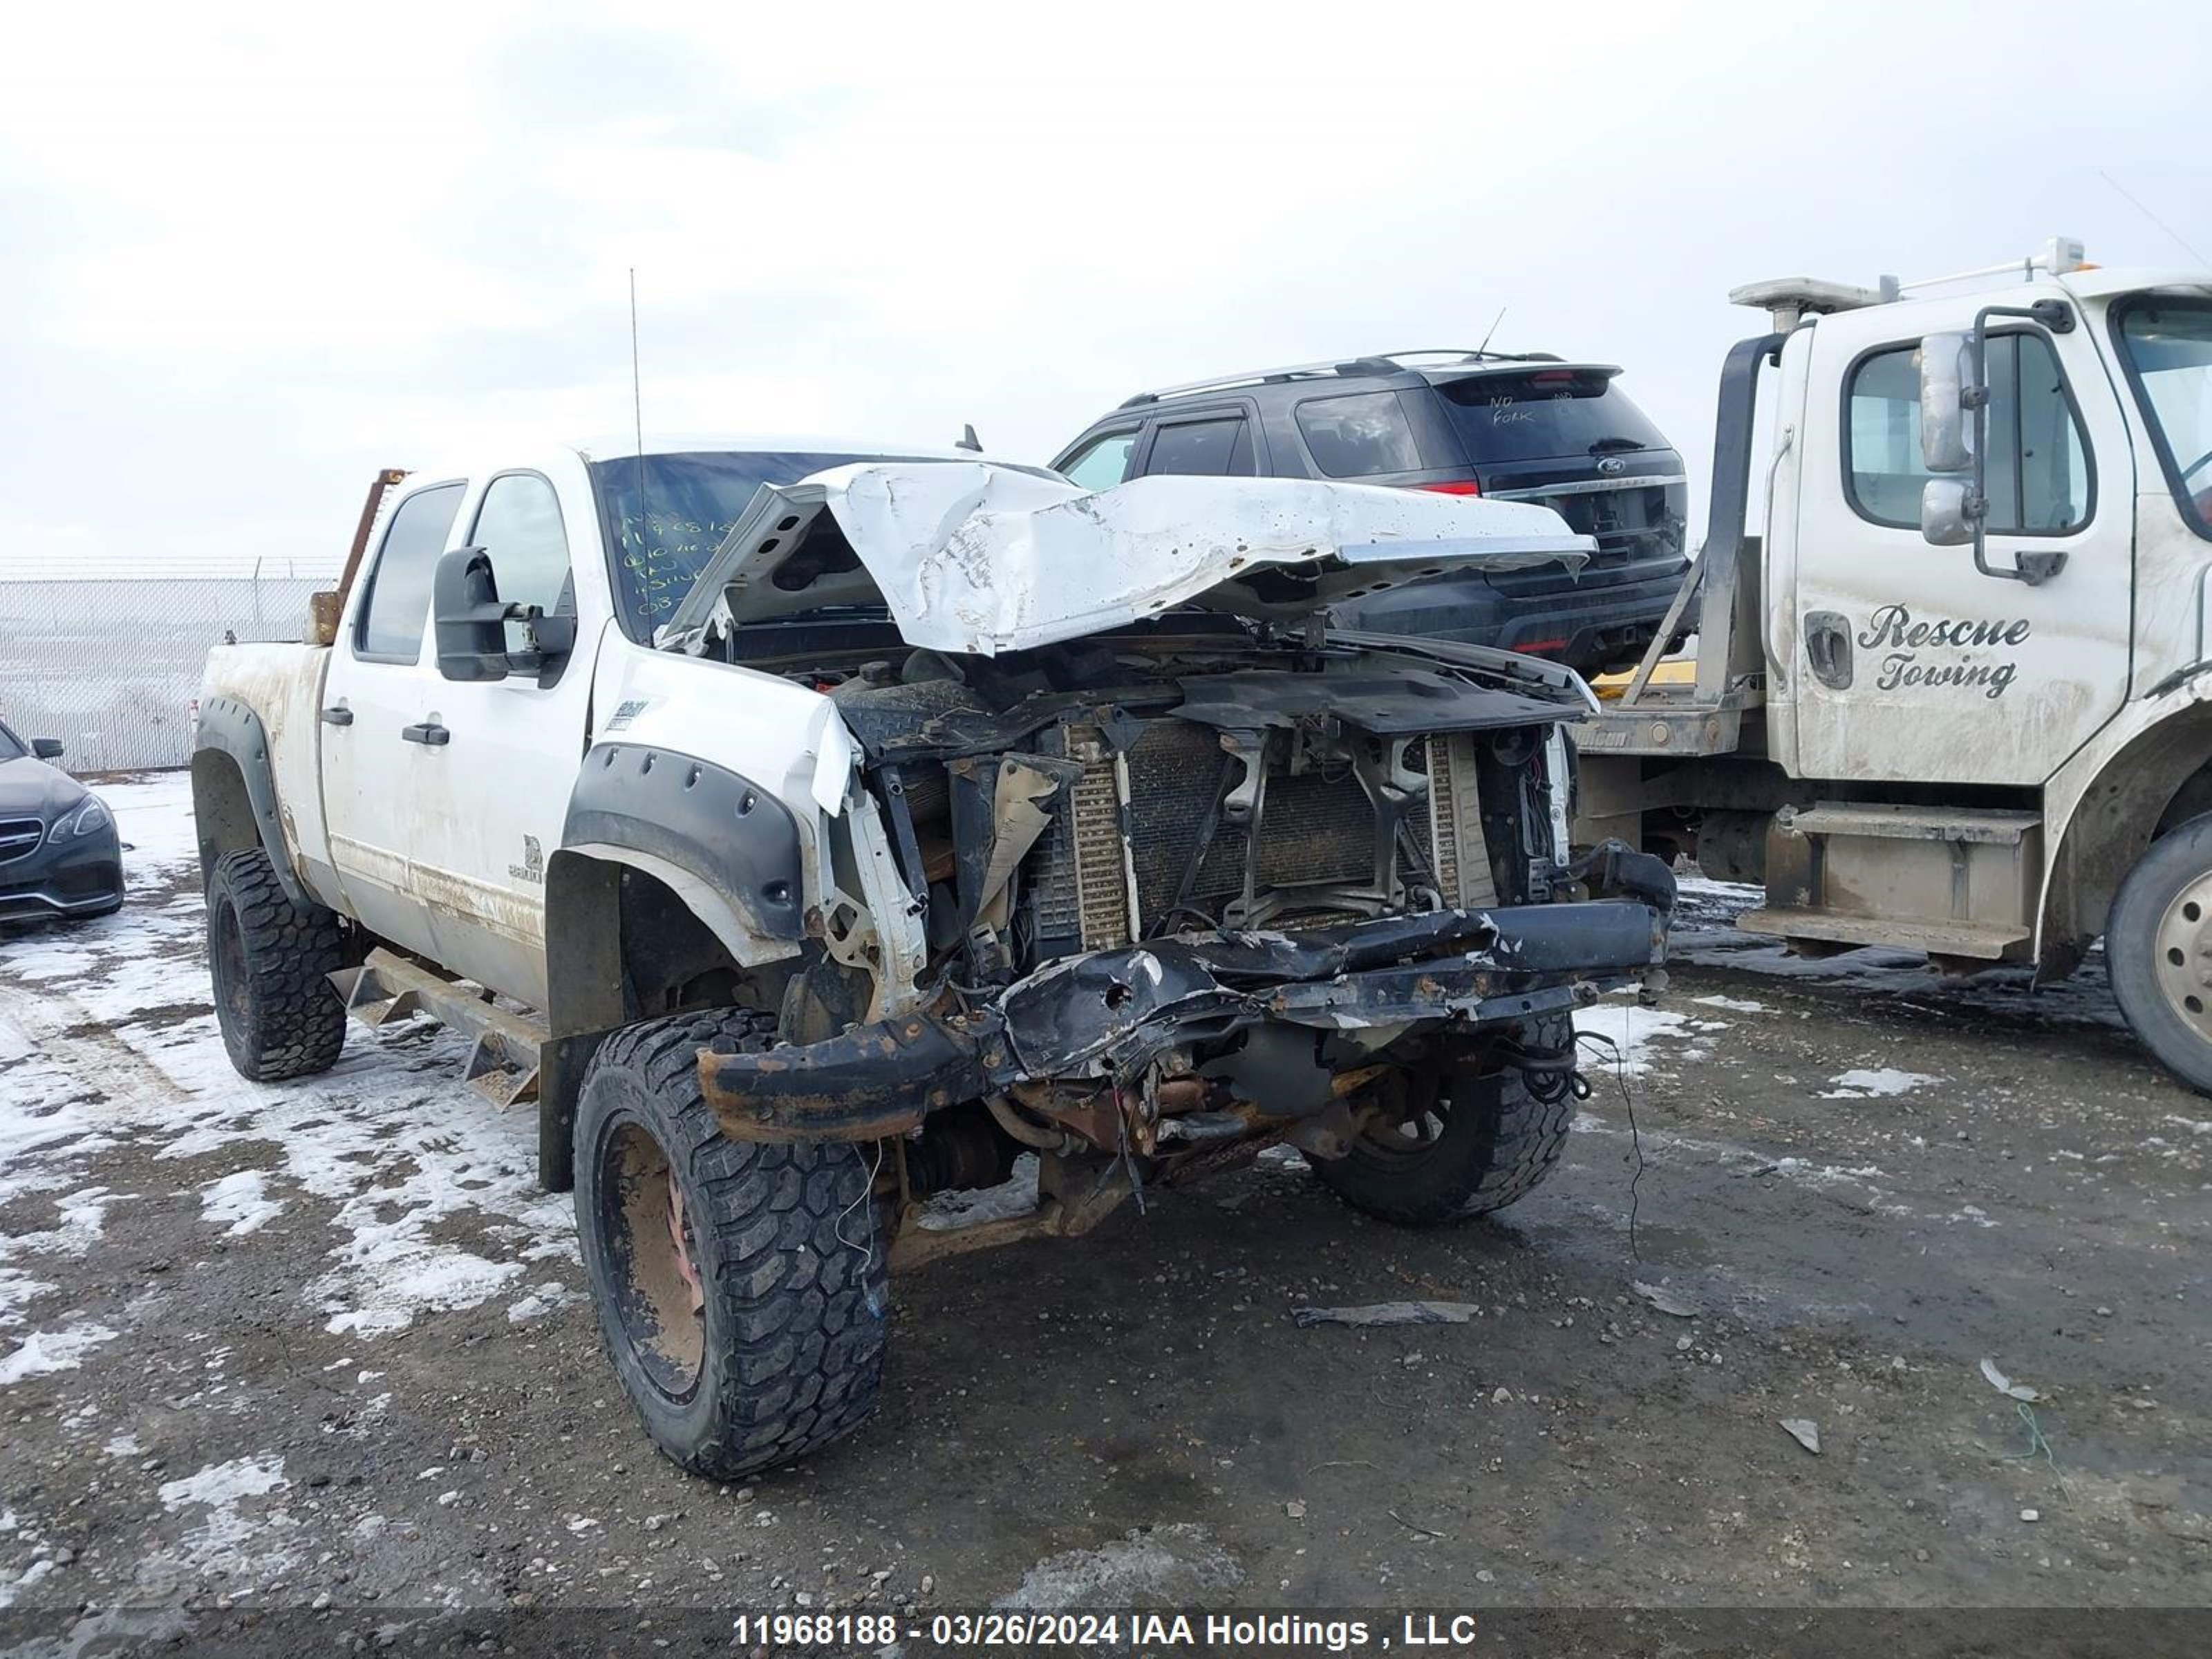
left=1053, top=350, right=1688, bottom=675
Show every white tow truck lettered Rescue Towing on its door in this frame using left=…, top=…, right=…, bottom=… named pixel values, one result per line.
left=1577, top=239, right=2212, bottom=1088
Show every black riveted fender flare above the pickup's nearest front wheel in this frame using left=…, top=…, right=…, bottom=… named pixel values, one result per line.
left=562, top=743, right=805, bottom=966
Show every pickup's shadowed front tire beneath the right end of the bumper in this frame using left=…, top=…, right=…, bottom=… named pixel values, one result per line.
left=1314, top=1015, right=1575, bottom=1228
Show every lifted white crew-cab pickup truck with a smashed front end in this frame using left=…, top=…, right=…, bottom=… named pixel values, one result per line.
left=192, top=440, right=1674, bottom=1478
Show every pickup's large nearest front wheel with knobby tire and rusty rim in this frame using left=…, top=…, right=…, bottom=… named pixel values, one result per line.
left=575, top=1011, right=889, bottom=1480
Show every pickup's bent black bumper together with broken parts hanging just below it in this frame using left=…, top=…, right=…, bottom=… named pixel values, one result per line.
left=701, top=858, right=1674, bottom=1157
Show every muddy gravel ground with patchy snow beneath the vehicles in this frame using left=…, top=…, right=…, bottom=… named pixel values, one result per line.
left=0, top=774, right=2212, bottom=1637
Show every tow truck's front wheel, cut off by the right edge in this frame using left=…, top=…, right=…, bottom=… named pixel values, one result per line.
left=2103, top=816, right=2212, bottom=1095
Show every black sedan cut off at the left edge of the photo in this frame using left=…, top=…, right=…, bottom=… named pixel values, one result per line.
left=0, top=721, right=124, bottom=922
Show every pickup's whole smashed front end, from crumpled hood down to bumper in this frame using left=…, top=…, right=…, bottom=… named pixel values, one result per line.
left=673, top=458, right=1674, bottom=1254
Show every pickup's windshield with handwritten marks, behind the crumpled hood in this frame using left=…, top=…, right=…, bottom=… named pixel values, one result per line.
left=590, top=449, right=887, bottom=639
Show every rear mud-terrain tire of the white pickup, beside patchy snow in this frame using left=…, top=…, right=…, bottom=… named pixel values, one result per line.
left=208, top=847, right=345, bottom=1084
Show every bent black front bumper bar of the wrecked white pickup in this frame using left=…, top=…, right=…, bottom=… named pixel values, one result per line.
left=699, top=847, right=1674, bottom=1141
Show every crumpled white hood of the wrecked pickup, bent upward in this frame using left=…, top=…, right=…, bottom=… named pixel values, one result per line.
left=662, top=462, right=1595, bottom=655
